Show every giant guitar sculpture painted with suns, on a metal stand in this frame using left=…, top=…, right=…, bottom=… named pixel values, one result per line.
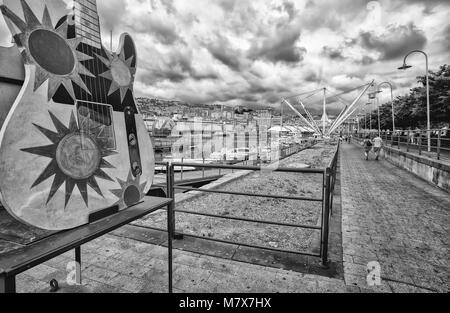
left=0, top=0, right=154, bottom=230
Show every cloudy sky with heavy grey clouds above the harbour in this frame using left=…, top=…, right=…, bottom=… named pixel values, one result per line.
left=0, top=0, right=450, bottom=111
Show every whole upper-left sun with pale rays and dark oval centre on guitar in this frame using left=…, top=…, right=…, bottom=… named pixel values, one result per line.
left=1, top=0, right=94, bottom=101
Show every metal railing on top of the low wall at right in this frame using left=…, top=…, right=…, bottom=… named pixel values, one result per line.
left=357, top=129, right=450, bottom=161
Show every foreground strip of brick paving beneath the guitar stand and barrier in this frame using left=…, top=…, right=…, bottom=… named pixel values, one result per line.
left=17, top=235, right=367, bottom=293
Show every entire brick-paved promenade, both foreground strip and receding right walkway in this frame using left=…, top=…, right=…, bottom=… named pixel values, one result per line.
left=12, top=144, right=450, bottom=292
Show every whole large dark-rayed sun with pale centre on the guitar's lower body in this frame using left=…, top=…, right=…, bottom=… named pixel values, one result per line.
left=22, top=112, right=116, bottom=207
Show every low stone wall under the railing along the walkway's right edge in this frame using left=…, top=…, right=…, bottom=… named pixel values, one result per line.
left=382, top=147, right=450, bottom=192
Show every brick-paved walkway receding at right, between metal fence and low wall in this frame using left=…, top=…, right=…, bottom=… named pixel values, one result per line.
left=341, top=144, right=450, bottom=292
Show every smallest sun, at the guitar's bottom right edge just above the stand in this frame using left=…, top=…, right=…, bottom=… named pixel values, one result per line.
left=110, top=171, right=147, bottom=209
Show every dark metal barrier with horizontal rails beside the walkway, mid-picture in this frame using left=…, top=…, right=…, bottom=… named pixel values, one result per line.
left=155, top=144, right=340, bottom=266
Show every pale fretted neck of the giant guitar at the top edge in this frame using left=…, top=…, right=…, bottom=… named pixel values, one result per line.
left=73, top=0, right=102, bottom=49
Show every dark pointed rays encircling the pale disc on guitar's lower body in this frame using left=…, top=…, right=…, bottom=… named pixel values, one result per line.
left=22, top=112, right=116, bottom=207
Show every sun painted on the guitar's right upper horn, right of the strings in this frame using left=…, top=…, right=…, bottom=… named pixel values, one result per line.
left=97, top=49, right=136, bottom=102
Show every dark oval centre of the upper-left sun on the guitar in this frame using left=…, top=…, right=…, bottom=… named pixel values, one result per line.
left=28, top=29, right=75, bottom=76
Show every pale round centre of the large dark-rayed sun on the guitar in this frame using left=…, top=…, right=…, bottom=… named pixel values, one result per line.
left=56, top=133, right=101, bottom=180
